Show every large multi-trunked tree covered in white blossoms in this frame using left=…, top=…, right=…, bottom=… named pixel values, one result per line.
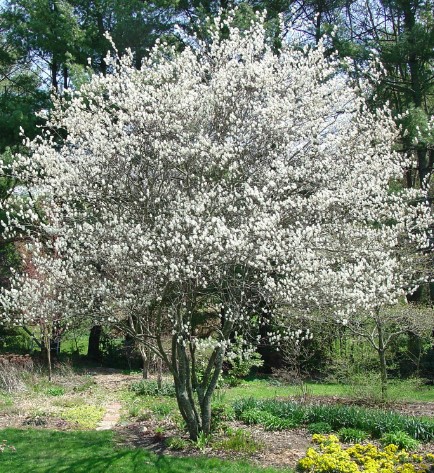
left=1, top=12, right=428, bottom=439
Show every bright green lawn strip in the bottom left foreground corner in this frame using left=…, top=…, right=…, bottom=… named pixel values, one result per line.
left=0, top=429, right=289, bottom=473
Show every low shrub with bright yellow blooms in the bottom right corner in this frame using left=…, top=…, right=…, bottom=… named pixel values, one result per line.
left=297, top=434, right=434, bottom=473
